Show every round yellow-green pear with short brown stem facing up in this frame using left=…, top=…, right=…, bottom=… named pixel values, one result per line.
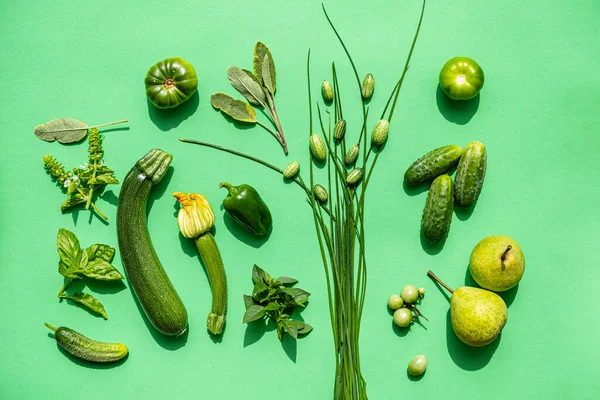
left=469, top=235, right=525, bottom=292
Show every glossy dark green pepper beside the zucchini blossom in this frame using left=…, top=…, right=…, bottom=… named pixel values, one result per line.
left=219, top=182, right=273, bottom=236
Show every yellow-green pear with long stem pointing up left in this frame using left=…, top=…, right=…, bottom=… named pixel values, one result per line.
left=427, top=271, right=508, bottom=347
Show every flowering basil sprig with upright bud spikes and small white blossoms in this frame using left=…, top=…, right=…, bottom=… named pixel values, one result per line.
left=44, top=128, right=119, bottom=220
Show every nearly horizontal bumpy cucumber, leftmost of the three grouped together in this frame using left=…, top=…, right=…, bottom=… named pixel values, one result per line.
left=404, top=144, right=462, bottom=185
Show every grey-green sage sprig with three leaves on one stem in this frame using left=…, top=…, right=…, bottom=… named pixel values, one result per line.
left=210, top=42, right=288, bottom=154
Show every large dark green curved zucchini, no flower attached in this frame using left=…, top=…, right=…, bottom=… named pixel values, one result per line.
left=117, top=149, right=188, bottom=336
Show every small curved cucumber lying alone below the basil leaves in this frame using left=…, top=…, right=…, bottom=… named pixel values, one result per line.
left=44, top=323, right=129, bottom=363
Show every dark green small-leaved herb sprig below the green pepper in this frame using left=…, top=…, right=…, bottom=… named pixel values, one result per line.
left=243, top=265, right=312, bottom=341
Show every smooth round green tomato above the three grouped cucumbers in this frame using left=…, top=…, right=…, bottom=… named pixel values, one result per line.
left=440, top=57, right=485, bottom=100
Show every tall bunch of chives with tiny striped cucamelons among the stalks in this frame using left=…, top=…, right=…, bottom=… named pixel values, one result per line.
left=180, top=0, right=426, bottom=400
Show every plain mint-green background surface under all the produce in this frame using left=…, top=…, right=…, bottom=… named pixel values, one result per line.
left=0, top=0, right=600, bottom=399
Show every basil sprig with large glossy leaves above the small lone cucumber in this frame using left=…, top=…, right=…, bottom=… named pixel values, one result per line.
left=56, top=228, right=123, bottom=319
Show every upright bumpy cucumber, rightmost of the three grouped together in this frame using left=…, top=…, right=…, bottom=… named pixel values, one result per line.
left=454, top=142, right=487, bottom=207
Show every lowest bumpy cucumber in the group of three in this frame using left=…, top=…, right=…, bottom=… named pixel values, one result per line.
left=421, top=174, right=454, bottom=243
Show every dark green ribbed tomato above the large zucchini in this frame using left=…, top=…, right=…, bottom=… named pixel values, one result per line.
left=145, top=57, right=198, bottom=108
